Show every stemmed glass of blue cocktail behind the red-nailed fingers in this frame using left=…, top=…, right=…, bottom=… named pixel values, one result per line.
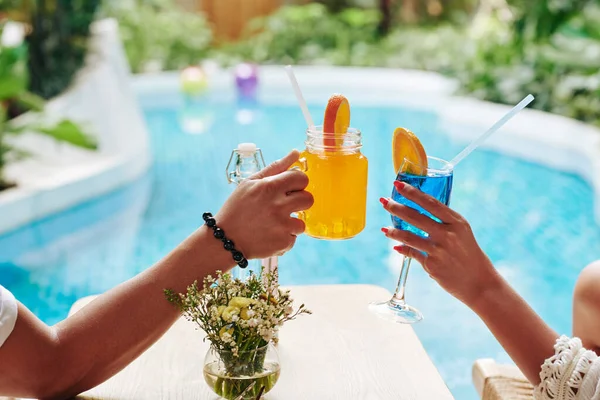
left=369, top=157, right=453, bottom=324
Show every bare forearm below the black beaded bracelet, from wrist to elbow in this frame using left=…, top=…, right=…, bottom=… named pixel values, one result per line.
left=35, top=228, right=233, bottom=398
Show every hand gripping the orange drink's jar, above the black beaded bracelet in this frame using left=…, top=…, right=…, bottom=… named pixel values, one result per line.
left=215, top=150, right=314, bottom=259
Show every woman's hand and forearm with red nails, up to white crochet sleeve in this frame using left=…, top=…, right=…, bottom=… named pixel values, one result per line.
left=381, top=182, right=558, bottom=385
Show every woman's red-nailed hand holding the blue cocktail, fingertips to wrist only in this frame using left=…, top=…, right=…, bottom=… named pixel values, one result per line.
left=381, top=181, right=498, bottom=306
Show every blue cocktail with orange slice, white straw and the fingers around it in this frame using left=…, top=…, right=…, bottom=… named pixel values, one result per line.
left=369, top=95, right=534, bottom=324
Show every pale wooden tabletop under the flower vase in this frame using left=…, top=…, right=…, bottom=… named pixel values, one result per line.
left=72, top=285, right=453, bottom=400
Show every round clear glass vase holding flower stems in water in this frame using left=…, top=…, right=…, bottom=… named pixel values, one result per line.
left=204, top=343, right=281, bottom=400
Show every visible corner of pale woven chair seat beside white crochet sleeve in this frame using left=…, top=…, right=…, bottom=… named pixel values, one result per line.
left=473, top=359, right=533, bottom=400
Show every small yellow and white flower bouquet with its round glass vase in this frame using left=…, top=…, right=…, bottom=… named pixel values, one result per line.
left=165, top=271, right=311, bottom=400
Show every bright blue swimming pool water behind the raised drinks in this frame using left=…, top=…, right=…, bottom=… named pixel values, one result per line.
left=0, top=94, right=600, bottom=400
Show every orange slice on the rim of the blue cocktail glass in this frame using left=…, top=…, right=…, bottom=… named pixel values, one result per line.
left=392, top=128, right=427, bottom=176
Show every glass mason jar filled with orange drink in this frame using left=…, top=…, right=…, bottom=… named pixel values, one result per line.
left=298, top=126, right=369, bottom=240
